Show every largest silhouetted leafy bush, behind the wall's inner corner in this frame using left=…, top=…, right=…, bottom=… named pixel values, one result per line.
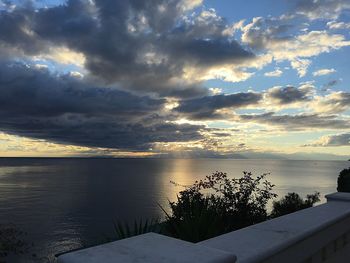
left=163, top=172, right=277, bottom=242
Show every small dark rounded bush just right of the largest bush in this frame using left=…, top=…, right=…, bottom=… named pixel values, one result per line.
left=271, top=192, right=320, bottom=218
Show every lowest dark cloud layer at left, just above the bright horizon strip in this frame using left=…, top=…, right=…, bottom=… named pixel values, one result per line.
left=1, top=115, right=204, bottom=150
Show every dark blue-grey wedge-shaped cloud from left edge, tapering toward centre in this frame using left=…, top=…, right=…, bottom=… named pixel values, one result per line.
left=0, top=62, right=165, bottom=117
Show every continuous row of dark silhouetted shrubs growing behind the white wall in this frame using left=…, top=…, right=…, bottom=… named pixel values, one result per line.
left=115, top=172, right=320, bottom=242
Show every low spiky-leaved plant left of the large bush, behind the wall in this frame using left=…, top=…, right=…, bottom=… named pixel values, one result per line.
left=114, top=219, right=161, bottom=239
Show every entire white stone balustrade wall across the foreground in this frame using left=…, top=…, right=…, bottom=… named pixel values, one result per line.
left=58, top=193, right=350, bottom=263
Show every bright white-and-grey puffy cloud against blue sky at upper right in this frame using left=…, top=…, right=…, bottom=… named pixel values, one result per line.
left=241, top=16, right=350, bottom=77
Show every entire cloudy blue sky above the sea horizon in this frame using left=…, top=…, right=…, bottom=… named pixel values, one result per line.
left=0, top=0, right=350, bottom=160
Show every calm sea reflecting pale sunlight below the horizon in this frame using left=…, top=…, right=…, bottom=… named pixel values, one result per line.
left=0, top=159, right=350, bottom=262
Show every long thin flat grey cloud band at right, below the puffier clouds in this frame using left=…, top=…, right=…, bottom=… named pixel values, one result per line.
left=238, top=112, right=350, bottom=130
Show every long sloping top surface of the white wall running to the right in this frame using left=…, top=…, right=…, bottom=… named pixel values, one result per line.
left=199, top=194, right=350, bottom=262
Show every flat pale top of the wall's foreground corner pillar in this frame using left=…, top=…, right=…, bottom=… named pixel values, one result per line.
left=58, top=233, right=236, bottom=263
